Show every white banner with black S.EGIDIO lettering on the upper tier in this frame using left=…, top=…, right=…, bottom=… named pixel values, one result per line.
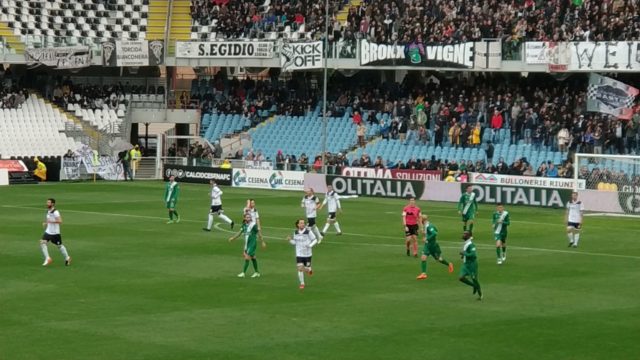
left=176, top=40, right=274, bottom=59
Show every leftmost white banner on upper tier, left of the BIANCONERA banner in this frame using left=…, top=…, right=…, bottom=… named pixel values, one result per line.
left=24, top=46, right=91, bottom=69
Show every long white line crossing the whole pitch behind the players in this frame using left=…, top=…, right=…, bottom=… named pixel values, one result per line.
left=5, top=205, right=640, bottom=260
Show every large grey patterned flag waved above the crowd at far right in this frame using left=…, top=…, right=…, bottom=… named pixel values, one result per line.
left=587, top=73, right=638, bottom=120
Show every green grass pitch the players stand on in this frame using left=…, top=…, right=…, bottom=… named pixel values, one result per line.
left=0, top=182, right=640, bottom=360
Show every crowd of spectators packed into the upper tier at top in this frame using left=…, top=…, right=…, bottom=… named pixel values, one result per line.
left=191, top=0, right=640, bottom=53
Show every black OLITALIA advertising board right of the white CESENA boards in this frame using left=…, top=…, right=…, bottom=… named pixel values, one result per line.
left=325, top=175, right=425, bottom=199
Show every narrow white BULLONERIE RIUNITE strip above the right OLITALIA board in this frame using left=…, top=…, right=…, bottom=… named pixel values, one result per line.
left=469, top=173, right=586, bottom=190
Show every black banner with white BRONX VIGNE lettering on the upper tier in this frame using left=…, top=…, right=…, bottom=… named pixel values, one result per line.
left=360, top=40, right=475, bottom=68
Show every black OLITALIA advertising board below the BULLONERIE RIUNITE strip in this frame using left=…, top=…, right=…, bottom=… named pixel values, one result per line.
left=460, top=183, right=572, bottom=208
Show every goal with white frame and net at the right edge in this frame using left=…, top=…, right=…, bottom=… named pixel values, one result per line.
left=574, top=153, right=640, bottom=215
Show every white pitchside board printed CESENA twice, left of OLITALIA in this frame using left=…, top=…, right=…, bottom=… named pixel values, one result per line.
left=231, top=169, right=305, bottom=191
